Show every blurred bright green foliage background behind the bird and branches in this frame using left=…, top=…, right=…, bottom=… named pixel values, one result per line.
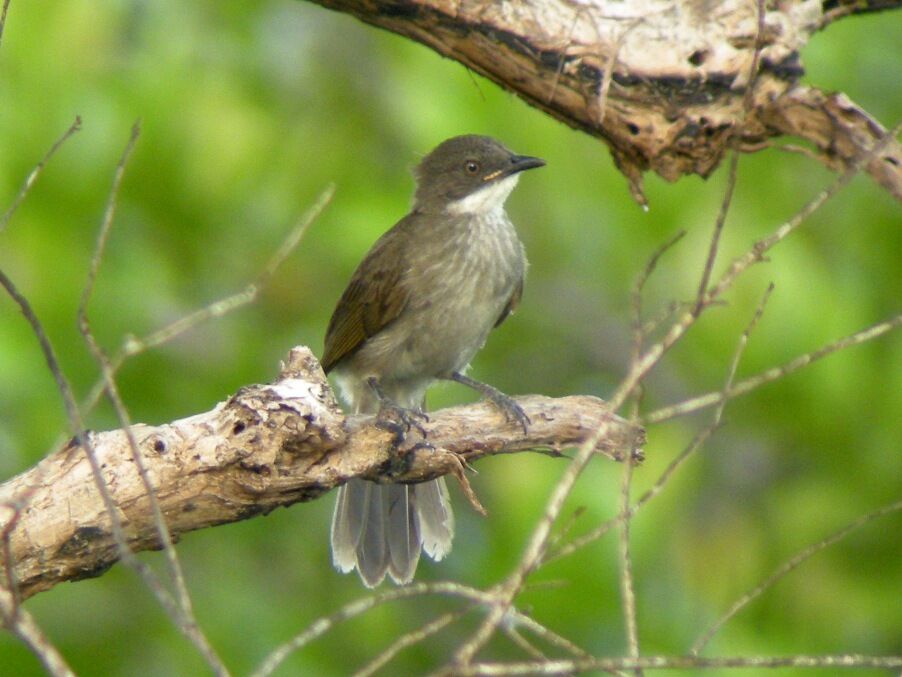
left=0, top=0, right=902, bottom=675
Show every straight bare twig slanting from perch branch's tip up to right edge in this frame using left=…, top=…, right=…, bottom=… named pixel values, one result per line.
left=641, top=314, right=902, bottom=426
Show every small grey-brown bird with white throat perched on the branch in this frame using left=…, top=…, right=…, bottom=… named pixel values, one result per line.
left=322, top=135, right=545, bottom=587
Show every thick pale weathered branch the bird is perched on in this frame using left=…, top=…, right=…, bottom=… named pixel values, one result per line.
left=0, top=348, right=644, bottom=599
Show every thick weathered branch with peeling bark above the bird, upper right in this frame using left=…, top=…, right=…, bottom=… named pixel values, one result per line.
left=314, top=0, right=902, bottom=204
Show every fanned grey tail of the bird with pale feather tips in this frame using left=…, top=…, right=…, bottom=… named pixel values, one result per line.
left=332, top=478, right=454, bottom=588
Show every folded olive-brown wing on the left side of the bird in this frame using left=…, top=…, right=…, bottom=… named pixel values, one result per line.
left=322, top=219, right=409, bottom=373
